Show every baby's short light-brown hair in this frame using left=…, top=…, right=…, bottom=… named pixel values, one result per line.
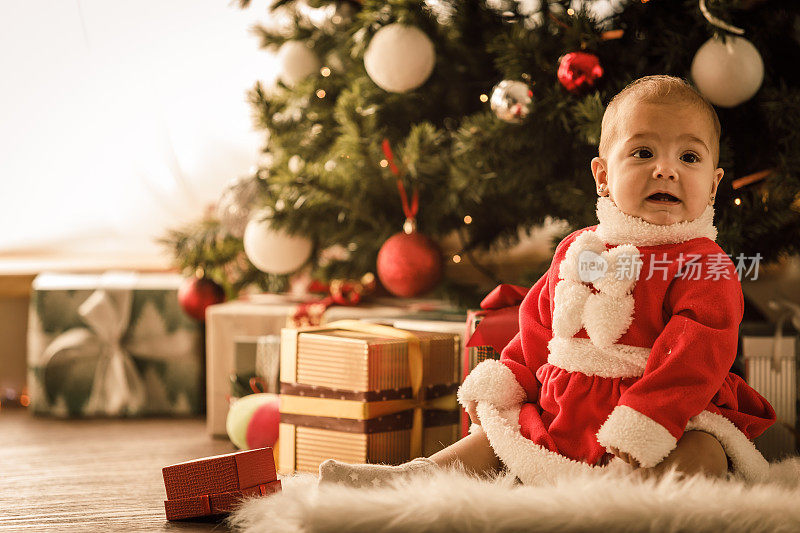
left=599, top=75, right=722, bottom=166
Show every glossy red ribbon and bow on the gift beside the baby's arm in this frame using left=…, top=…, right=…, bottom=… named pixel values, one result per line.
left=467, top=284, right=529, bottom=353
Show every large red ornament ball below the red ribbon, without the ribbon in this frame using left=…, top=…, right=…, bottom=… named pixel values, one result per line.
left=377, top=231, right=442, bottom=298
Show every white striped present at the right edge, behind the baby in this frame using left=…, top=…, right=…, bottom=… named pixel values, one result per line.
left=739, top=300, right=800, bottom=460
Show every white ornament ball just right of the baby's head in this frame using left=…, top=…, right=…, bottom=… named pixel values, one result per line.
left=692, top=36, right=764, bottom=107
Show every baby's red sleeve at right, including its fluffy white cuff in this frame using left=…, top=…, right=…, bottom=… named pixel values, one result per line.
left=597, top=250, right=744, bottom=467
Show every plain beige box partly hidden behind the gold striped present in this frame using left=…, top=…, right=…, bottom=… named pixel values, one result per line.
left=206, top=294, right=454, bottom=437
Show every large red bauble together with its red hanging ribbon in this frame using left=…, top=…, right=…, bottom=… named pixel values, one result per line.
left=377, top=140, right=443, bottom=298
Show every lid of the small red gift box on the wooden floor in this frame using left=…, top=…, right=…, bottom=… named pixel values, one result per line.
left=162, top=448, right=278, bottom=500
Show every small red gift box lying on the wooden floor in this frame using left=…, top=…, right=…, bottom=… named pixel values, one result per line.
left=162, top=448, right=281, bottom=520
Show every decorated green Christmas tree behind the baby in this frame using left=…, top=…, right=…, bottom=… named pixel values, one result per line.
left=167, top=0, right=800, bottom=304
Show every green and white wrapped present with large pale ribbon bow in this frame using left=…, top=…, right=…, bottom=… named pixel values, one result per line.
left=28, top=272, right=204, bottom=417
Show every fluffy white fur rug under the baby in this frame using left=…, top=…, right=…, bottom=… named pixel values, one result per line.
left=229, top=458, right=800, bottom=533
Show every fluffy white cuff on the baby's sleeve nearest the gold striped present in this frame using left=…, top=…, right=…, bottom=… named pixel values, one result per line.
left=458, top=359, right=528, bottom=407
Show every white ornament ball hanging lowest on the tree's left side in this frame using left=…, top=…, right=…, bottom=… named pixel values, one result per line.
left=244, top=217, right=312, bottom=274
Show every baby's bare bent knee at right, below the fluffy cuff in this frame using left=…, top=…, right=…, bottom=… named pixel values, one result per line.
left=637, top=431, right=728, bottom=477
